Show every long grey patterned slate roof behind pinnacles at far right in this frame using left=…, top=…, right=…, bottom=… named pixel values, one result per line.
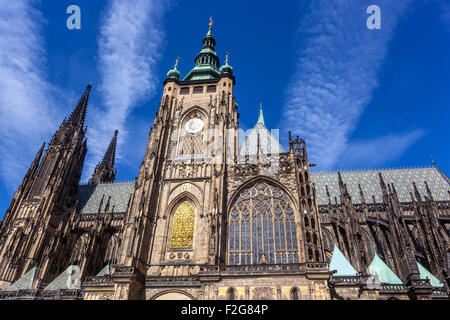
left=311, top=167, right=450, bottom=205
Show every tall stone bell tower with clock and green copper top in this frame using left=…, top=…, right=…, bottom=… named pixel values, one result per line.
left=116, top=19, right=238, bottom=297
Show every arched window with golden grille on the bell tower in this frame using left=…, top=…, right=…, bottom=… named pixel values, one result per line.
left=170, top=201, right=195, bottom=249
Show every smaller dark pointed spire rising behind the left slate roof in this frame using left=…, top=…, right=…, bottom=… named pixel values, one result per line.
left=88, top=130, right=119, bottom=184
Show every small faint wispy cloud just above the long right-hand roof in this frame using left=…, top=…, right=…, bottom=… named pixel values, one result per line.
left=340, top=129, right=427, bottom=168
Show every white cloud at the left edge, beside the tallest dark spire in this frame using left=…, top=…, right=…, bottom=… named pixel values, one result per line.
left=0, top=0, right=57, bottom=190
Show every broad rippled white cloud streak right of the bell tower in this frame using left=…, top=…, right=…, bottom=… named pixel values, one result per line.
left=282, top=0, right=417, bottom=169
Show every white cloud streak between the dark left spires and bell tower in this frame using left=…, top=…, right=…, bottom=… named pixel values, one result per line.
left=84, top=0, right=168, bottom=175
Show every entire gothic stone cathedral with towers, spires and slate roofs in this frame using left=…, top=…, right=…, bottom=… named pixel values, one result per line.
left=0, top=24, right=450, bottom=300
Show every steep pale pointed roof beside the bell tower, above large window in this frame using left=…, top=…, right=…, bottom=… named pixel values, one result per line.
left=239, top=122, right=286, bottom=156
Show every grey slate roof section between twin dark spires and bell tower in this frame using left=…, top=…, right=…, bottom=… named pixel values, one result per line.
left=77, top=182, right=134, bottom=214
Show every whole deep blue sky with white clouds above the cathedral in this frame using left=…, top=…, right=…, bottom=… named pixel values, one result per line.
left=0, top=0, right=450, bottom=216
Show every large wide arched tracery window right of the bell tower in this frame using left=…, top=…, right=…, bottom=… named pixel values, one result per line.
left=228, top=182, right=299, bottom=265
